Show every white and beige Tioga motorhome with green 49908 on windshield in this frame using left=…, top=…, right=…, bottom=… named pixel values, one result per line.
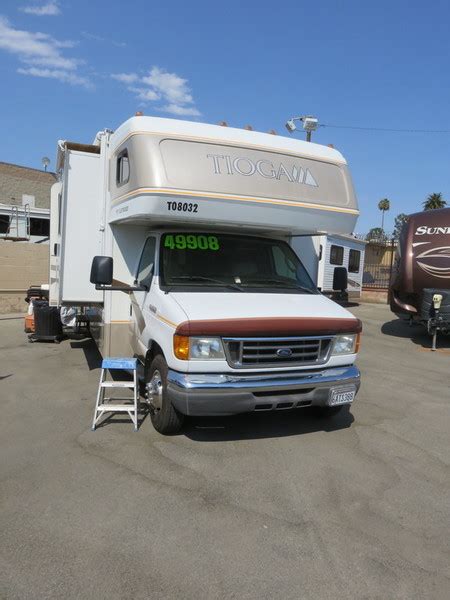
left=50, top=117, right=361, bottom=433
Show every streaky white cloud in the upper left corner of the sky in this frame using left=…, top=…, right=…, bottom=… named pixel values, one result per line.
left=0, top=16, right=91, bottom=87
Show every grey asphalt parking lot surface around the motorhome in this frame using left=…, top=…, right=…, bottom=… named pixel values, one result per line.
left=0, top=304, right=450, bottom=600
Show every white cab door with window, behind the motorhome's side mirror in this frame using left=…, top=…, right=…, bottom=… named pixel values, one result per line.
left=130, top=235, right=156, bottom=356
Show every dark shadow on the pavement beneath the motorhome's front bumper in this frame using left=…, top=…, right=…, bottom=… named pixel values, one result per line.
left=182, top=407, right=354, bottom=442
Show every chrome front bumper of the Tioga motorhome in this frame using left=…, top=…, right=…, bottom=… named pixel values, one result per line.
left=167, top=365, right=360, bottom=416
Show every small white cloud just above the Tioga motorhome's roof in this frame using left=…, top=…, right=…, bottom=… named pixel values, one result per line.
left=111, top=66, right=201, bottom=117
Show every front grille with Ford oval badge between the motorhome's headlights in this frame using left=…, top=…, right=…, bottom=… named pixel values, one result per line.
left=223, top=336, right=333, bottom=369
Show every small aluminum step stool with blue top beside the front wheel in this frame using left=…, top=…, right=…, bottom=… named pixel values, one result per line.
left=92, top=358, right=139, bottom=431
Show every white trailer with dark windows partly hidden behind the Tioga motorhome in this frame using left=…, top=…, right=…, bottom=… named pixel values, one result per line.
left=292, top=234, right=367, bottom=300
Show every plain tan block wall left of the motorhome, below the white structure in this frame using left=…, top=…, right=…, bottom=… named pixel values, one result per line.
left=0, top=240, right=50, bottom=314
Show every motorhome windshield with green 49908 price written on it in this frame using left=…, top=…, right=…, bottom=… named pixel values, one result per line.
left=160, top=232, right=318, bottom=294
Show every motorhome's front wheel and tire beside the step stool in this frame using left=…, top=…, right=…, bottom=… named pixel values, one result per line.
left=145, top=354, right=184, bottom=435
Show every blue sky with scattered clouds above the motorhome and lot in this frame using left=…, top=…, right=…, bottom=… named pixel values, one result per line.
left=0, top=0, right=450, bottom=232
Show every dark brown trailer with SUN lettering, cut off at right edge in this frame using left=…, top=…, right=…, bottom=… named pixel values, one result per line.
left=389, top=208, right=450, bottom=349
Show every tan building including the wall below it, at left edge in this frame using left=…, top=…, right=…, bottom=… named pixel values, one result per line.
left=0, top=162, right=56, bottom=314
